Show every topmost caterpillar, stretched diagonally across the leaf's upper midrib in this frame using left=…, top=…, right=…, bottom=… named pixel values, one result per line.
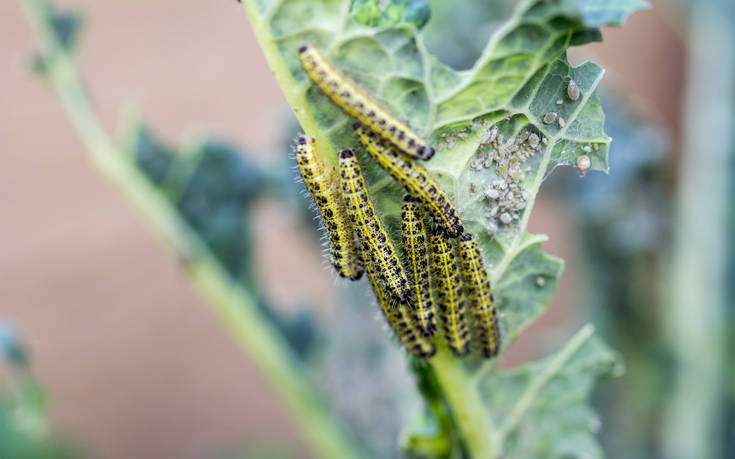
left=299, top=45, right=435, bottom=160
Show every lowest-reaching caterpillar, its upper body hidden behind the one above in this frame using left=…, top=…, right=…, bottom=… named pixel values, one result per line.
left=360, top=247, right=436, bottom=359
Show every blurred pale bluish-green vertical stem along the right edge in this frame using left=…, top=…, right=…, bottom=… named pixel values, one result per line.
left=662, top=0, right=735, bottom=459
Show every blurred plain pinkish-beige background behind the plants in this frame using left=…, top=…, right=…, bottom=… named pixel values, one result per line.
left=0, top=0, right=683, bottom=458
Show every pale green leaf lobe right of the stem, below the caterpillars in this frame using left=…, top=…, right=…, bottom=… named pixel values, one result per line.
left=479, top=325, right=622, bottom=459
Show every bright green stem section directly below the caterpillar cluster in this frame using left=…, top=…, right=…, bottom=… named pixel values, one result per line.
left=431, top=345, right=501, bottom=459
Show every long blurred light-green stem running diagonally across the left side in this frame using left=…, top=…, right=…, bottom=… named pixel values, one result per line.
left=23, top=0, right=360, bottom=459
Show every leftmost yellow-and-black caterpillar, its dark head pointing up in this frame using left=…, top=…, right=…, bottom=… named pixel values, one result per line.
left=296, top=135, right=362, bottom=280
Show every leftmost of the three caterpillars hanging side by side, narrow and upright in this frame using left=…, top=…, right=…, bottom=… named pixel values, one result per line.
left=401, top=195, right=436, bottom=336
